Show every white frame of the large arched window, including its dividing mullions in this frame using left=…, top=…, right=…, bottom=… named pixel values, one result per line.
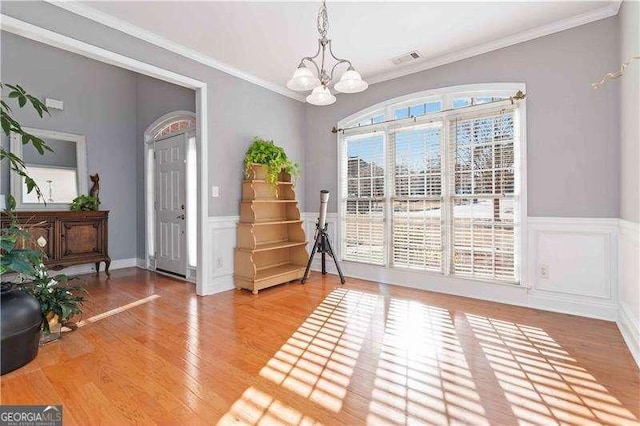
left=335, top=83, right=528, bottom=287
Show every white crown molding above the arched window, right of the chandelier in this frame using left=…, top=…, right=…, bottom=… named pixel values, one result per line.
left=366, top=1, right=622, bottom=84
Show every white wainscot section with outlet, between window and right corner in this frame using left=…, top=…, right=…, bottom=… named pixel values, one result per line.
left=526, top=218, right=618, bottom=321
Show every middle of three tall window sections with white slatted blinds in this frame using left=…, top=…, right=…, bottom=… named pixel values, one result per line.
left=389, top=123, right=442, bottom=271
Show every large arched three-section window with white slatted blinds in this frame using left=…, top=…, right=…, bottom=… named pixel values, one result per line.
left=339, top=85, right=522, bottom=283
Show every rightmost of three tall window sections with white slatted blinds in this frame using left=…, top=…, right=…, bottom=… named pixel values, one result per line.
left=448, top=110, right=519, bottom=282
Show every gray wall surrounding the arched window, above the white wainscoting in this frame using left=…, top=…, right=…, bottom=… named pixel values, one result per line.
left=305, top=17, right=620, bottom=217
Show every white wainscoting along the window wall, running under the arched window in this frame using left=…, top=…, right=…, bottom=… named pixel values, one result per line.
left=303, top=213, right=618, bottom=321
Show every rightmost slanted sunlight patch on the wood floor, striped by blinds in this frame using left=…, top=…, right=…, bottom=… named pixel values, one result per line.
left=465, top=314, right=640, bottom=425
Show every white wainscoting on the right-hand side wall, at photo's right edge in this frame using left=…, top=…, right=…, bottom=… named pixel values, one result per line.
left=617, top=219, right=640, bottom=366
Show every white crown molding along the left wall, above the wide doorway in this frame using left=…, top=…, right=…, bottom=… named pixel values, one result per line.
left=44, top=0, right=305, bottom=102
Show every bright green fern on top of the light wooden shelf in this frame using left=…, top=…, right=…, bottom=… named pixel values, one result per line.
left=244, top=136, right=300, bottom=187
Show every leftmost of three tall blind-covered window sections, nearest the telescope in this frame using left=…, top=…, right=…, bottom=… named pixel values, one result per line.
left=341, top=133, right=386, bottom=265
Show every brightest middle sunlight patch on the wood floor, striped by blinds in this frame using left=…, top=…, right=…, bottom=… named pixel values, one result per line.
left=367, top=299, right=489, bottom=425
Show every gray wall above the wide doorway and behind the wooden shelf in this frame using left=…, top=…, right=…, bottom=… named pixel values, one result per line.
left=1, top=1, right=306, bottom=216
